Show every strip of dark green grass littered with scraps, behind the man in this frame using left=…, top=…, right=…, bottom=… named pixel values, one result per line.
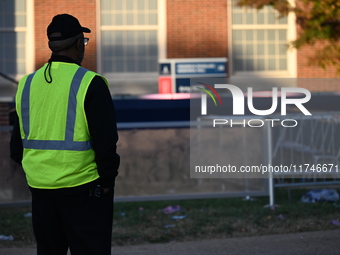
left=0, top=189, right=340, bottom=247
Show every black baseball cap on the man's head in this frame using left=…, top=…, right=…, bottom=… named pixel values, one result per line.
left=47, top=14, right=91, bottom=41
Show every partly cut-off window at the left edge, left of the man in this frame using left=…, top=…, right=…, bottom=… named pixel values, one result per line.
left=0, top=0, right=27, bottom=76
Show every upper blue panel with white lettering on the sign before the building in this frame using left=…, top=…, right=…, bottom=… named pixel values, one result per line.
left=176, top=62, right=226, bottom=75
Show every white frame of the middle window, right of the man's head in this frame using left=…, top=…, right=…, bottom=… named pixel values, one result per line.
left=96, top=0, right=167, bottom=82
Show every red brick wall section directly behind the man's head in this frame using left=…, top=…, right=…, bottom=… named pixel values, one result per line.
left=34, top=0, right=97, bottom=70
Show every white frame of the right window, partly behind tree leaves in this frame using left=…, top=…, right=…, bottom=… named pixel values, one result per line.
left=227, top=0, right=297, bottom=78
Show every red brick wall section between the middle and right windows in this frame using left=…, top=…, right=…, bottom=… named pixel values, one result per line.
left=167, top=0, right=228, bottom=58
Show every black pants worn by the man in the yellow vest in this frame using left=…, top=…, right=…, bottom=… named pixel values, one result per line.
left=32, top=186, right=113, bottom=255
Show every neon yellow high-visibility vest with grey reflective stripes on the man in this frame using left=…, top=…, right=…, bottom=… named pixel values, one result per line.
left=16, top=62, right=107, bottom=189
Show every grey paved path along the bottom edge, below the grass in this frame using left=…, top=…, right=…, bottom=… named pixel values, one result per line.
left=0, top=229, right=340, bottom=255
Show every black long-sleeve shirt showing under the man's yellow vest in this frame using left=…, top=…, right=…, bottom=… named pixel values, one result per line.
left=10, top=55, right=120, bottom=192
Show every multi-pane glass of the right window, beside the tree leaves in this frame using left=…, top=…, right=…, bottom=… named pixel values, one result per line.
left=231, top=1, right=295, bottom=73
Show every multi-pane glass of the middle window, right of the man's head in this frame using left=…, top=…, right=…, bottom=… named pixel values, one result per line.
left=100, top=0, right=159, bottom=74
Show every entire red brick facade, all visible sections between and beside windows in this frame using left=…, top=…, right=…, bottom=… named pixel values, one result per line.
left=29, top=0, right=340, bottom=91
